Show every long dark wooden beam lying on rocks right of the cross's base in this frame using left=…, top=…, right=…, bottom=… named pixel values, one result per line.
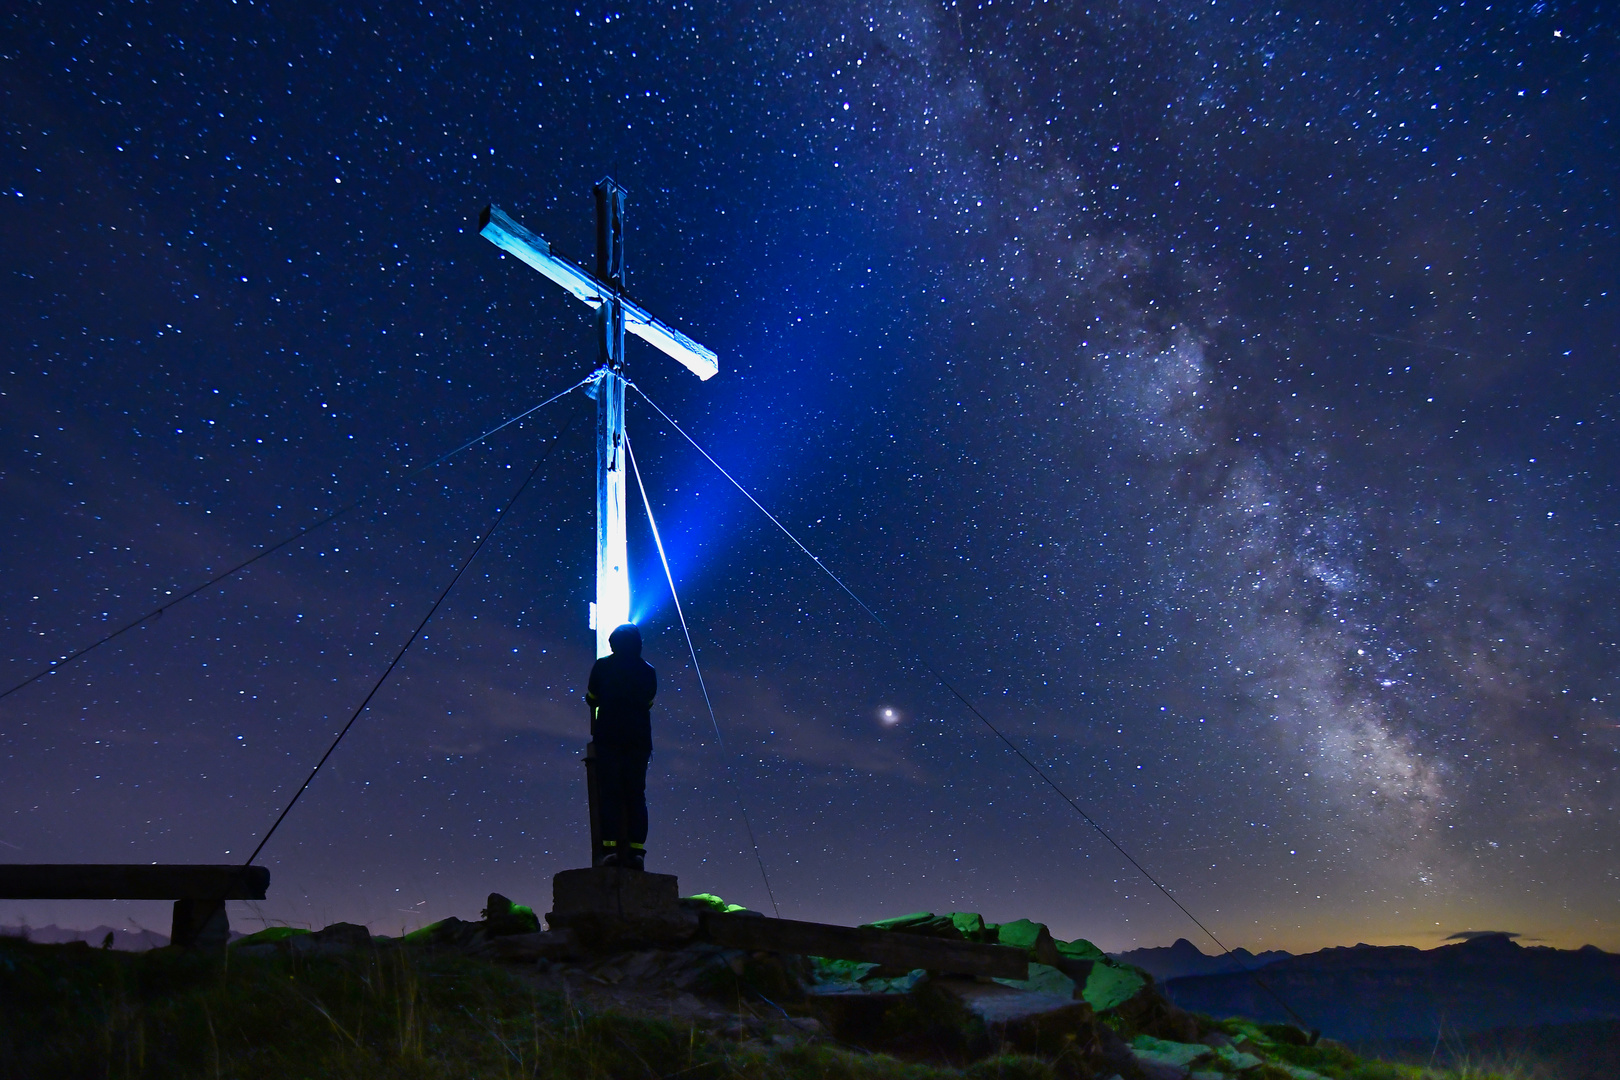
left=703, top=912, right=1029, bottom=978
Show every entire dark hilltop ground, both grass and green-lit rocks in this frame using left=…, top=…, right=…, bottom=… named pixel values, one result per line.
left=0, top=894, right=1533, bottom=1080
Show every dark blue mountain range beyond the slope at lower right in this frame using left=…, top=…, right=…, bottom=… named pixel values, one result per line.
left=1163, top=934, right=1620, bottom=1043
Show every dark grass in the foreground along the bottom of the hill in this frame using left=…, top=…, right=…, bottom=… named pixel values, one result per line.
left=0, top=939, right=1555, bottom=1080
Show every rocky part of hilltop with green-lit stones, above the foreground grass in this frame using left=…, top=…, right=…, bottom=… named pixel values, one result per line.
left=218, top=897, right=1490, bottom=1080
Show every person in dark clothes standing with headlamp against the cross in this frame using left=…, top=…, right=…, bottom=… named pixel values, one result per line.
left=585, top=622, right=658, bottom=870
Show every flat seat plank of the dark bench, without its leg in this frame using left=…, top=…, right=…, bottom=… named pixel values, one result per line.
left=0, top=863, right=271, bottom=900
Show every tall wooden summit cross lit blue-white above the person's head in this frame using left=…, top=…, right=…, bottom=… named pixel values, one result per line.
left=478, top=178, right=719, bottom=656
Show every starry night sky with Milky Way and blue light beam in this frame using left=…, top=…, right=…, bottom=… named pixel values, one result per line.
left=0, top=0, right=1620, bottom=950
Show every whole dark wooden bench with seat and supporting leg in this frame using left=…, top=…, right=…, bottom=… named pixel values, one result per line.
left=0, top=863, right=271, bottom=947
